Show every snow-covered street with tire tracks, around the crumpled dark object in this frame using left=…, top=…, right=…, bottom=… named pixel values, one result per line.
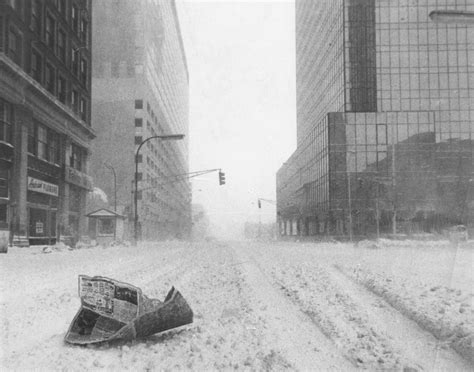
left=0, top=241, right=474, bottom=371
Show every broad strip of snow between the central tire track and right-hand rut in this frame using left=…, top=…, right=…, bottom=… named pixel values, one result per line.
left=244, top=241, right=470, bottom=371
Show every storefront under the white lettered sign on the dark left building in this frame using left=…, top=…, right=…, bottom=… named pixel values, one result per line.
left=27, top=176, right=59, bottom=245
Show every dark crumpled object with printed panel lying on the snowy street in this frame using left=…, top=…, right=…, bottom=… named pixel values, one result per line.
left=65, top=275, right=193, bottom=345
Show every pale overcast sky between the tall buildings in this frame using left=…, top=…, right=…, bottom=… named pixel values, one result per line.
left=177, top=0, right=296, bottom=238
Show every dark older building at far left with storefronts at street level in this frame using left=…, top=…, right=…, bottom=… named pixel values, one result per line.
left=0, top=0, right=95, bottom=246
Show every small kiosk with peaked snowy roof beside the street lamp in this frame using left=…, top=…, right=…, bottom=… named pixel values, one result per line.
left=86, top=208, right=125, bottom=245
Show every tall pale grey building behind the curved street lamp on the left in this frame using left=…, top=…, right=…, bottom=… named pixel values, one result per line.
left=92, top=0, right=191, bottom=239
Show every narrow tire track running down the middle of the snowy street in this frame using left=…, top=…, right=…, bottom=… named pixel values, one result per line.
left=234, top=241, right=355, bottom=371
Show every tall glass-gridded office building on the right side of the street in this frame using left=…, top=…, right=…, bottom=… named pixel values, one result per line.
left=277, top=0, right=474, bottom=236
